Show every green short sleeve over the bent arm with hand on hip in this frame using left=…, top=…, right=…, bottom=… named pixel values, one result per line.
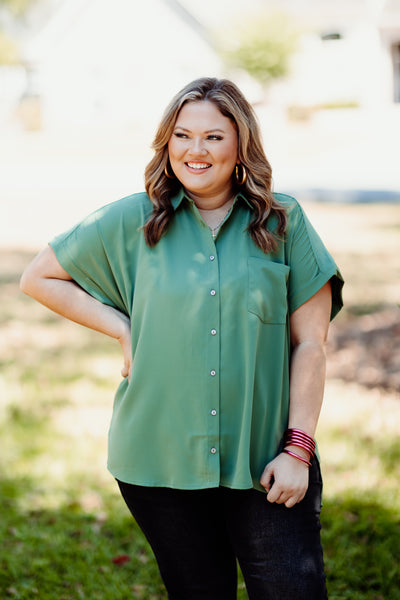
left=50, top=207, right=128, bottom=314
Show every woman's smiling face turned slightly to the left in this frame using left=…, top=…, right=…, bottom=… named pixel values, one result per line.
left=168, top=101, right=238, bottom=201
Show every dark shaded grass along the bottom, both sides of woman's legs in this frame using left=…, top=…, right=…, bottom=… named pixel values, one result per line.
left=0, top=477, right=400, bottom=600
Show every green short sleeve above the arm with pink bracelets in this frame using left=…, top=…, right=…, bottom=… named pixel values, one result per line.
left=287, top=202, right=344, bottom=319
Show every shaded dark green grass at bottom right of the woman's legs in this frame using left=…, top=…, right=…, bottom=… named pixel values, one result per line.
left=322, top=491, right=400, bottom=600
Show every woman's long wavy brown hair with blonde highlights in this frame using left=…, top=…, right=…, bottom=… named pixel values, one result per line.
left=144, top=77, right=287, bottom=253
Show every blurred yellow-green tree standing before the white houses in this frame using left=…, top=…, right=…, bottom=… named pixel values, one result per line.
left=219, top=12, right=299, bottom=86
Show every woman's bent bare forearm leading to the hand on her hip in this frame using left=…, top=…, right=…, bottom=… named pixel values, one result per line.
left=21, top=277, right=129, bottom=340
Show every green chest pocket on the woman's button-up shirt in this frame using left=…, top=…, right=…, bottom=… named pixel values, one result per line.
left=247, top=257, right=290, bottom=323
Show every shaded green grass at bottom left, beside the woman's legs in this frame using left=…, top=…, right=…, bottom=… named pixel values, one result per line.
left=0, top=477, right=166, bottom=600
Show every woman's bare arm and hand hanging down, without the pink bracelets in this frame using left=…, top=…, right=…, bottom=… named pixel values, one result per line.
left=260, top=282, right=332, bottom=508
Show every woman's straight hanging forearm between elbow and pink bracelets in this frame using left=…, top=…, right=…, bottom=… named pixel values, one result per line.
left=288, top=341, right=326, bottom=437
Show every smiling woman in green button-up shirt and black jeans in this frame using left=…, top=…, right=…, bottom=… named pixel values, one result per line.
left=21, top=78, right=343, bottom=600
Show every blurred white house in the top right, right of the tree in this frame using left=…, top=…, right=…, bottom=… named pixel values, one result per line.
left=272, top=0, right=400, bottom=108
